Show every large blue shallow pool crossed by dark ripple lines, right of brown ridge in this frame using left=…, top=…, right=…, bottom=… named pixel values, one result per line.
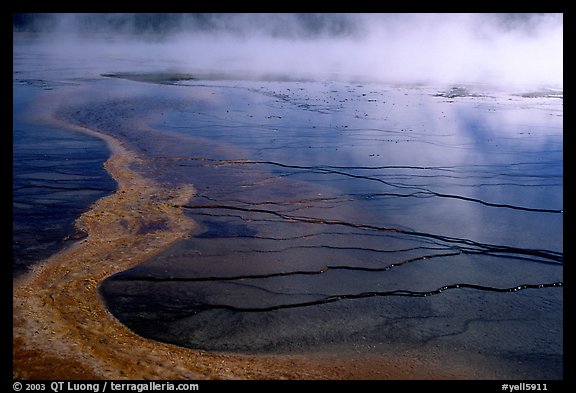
left=12, top=35, right=563, bottom=379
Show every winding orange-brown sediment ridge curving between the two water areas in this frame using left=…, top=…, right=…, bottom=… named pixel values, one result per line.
left=13, top=121, right=489, bottom=380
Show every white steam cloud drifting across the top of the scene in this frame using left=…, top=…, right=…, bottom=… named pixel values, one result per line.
left=13, top=14, right=563, bottom=87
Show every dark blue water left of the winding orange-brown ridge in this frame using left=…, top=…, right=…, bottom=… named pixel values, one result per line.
left=12, top=82, right=116, bottom=277
